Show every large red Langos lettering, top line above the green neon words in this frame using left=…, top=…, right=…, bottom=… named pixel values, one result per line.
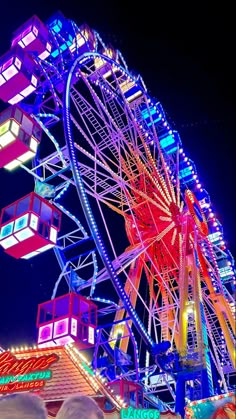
left=0, top=352, right=59, bottom=377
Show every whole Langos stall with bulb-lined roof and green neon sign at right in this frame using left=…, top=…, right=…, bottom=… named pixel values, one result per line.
left=0, top=343, right=180, bottom=419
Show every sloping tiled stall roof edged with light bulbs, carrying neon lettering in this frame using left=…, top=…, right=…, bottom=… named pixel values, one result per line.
left=0, top=345, right=125, bottom=411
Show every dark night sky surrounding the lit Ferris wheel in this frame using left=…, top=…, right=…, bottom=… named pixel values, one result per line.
left=0, top=0, right=233, bottom=347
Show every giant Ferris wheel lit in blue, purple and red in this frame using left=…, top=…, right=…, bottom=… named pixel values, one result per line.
left=0, top=9, right=235, bottom=411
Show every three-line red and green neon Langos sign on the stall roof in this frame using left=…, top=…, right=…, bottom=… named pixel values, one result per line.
left=0, top=352, right=59, bottom=393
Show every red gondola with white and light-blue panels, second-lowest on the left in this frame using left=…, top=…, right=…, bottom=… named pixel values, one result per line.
left=0, top=192, right=61, bottom=259
